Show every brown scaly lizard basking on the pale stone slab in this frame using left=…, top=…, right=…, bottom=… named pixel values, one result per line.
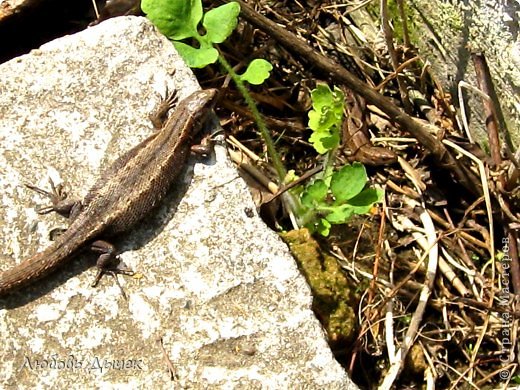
left=0, top=89, right=217, bottom=296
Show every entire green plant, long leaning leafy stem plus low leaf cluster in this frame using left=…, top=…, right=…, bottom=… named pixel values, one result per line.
left=141, top=0, right=381, bottom=236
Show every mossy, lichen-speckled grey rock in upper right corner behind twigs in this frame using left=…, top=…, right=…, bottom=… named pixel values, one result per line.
left=408, top=0, right=520, bottom=148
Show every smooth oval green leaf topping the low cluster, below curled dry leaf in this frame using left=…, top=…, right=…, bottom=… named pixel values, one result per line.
left=330, top=162, right=368, bottom=204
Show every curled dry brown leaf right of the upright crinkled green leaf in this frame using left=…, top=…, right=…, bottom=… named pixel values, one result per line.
left=342, top=91, right=397, bottom=165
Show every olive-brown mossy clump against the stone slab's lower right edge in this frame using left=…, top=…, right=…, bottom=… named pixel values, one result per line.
left=281, top=229, right=358, bottom=342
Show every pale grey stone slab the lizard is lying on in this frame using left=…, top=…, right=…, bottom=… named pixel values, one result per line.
left=0, top=17, right=355, bottom=389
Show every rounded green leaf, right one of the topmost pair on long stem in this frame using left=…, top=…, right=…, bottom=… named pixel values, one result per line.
left=202, top=2, right=242, bottom=43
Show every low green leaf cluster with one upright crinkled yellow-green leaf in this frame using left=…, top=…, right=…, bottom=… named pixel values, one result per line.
left=300, top=85, right=383, bottom=236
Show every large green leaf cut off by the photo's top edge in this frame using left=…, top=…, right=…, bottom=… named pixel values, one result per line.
left=141, top=0, right=202, bottom=40
